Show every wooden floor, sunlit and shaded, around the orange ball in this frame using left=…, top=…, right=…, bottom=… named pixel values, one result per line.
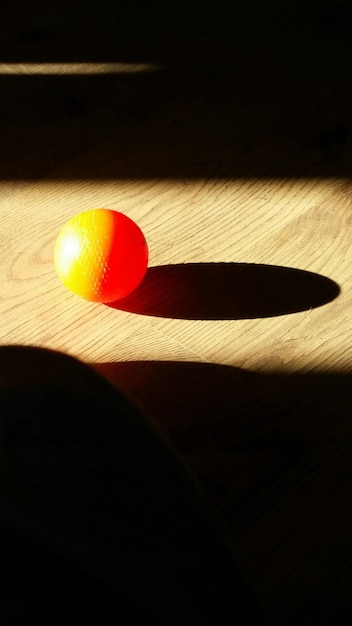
left=0, top=0, right=352, bottom=626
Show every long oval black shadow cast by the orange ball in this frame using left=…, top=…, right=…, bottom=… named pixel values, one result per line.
left=108, top=263, right=340, bottom=320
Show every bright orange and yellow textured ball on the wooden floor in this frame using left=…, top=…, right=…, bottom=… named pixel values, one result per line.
left=54, top=209, right=148, bottom=303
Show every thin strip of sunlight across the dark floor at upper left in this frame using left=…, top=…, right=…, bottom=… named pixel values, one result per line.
left=0, top=63, right=162, bottom=76
